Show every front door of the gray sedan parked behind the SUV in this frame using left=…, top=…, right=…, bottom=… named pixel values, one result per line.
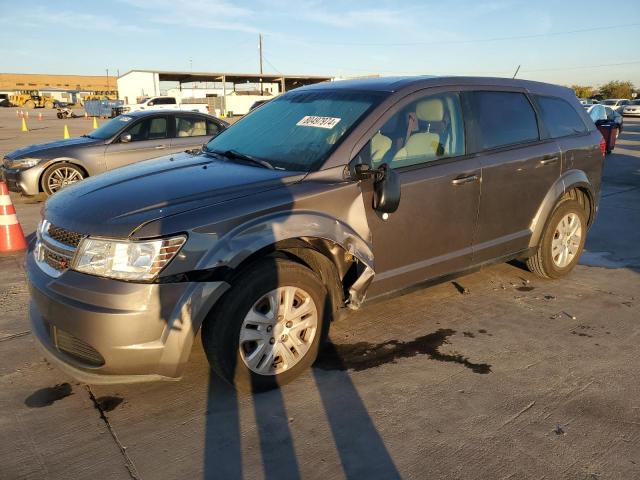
left=105, top=114, right=171, bottom=170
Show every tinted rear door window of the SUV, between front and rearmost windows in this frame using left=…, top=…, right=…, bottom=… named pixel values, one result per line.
left=466, top=92, right=540, bottom=150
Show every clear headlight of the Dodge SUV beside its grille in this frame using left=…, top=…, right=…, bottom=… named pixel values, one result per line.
left=73, top=236, right=186, bottom=280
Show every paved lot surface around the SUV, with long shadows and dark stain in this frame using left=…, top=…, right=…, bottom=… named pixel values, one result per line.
left=0, top=109, right=640, bottom=479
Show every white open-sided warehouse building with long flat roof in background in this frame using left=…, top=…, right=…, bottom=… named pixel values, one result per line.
left=117, top=70, right=331, bottom=115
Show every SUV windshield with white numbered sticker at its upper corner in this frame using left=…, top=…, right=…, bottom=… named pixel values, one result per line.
left=207, top=90, right=385, bottom=172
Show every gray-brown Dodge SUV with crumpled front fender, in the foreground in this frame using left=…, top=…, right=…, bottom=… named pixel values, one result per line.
left=26, top=77, right=605, bottom=391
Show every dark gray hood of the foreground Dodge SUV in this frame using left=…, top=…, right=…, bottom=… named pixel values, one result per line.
left=44, top=153, right=305, bottom=238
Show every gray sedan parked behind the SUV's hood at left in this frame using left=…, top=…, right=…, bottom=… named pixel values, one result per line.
left=0, top=110, right=228, bottom=195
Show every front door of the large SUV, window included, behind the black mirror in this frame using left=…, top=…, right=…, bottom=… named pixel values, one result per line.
left=360, top=92, right=480, bottom=298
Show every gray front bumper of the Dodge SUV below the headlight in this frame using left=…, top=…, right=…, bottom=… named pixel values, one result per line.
left=26, top=250, right=229, bottom=384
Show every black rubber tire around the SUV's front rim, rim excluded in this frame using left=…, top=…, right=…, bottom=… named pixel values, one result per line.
left=202, top=258, right=331, bottom=392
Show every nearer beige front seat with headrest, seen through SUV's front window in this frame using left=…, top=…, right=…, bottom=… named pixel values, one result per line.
left=393, top=98, right=444, bottom=161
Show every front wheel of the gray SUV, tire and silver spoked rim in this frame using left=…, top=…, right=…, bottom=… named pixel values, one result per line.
left=202, top=258, right=331, bottom=392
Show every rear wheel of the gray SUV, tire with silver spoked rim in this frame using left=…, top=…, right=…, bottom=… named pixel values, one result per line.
left=527, top=200, right=587, bottom=278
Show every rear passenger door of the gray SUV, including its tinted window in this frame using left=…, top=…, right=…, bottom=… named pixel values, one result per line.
left=464, top=89, right=561, bottom=264
